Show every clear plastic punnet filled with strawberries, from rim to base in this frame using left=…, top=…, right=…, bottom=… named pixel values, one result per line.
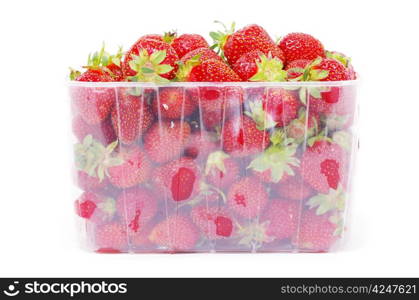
left=69, top=81, right=358, bottom=253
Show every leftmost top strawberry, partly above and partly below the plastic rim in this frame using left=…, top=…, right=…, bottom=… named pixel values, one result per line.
left=70, top=79, right=115, bottom=124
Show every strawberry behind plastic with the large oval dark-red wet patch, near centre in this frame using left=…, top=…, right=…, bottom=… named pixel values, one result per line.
left=151, top=158, right=200, bottom=201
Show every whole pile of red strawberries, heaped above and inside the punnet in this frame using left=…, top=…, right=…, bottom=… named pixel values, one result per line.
left=70, top=25, right=356, bottom=253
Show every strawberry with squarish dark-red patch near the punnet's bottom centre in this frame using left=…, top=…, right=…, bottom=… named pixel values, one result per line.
left=191, top=205, right=234, bottom=240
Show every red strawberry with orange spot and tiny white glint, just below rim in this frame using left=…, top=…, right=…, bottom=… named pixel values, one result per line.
left=152, top=87, right=197, bottom=119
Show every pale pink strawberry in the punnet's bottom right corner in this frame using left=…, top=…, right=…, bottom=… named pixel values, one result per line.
left=292, top=210, right=339, bottom=252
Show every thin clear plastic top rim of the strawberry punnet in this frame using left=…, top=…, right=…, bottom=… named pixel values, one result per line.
left=67, top=79, right=359, bottom=88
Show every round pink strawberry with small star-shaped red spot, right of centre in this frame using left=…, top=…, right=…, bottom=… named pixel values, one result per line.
left=227, top=177, right=268, bottom=219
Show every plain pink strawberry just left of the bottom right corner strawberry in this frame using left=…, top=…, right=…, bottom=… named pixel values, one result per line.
left=261, top=199, right=300, bottom=240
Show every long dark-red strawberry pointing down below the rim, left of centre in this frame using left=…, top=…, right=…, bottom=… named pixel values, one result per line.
left=111, top=89, right=153, bottom=145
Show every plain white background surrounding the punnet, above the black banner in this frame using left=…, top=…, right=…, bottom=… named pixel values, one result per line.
left=0, top=0, right=419, bottom=277
